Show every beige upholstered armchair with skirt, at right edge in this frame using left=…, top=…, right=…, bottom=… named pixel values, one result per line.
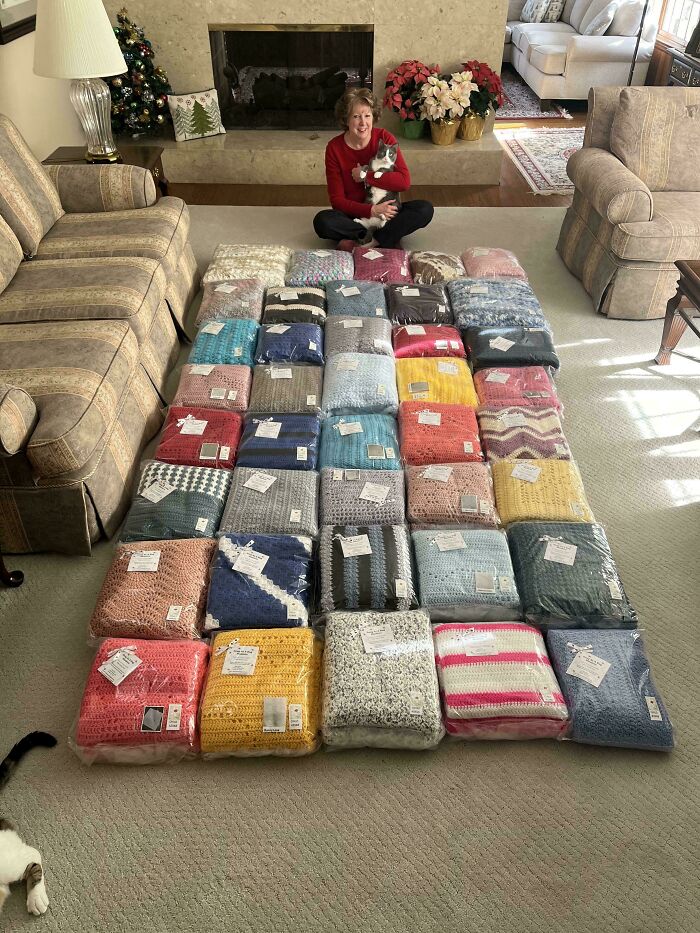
left=557, top=87, right=700, bottom=319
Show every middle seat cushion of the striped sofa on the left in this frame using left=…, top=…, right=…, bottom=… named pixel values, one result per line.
left=0, top=256, right=166, bottom=345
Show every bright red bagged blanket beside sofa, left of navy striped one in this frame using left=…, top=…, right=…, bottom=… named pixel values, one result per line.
left=155, top=405, right=243, bottom=470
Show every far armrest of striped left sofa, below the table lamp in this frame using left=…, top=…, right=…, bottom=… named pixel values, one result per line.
left=44, top=165, right=156, bottom=214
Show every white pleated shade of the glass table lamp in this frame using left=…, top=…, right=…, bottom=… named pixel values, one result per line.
left=34, top=0, right=128, bottom=78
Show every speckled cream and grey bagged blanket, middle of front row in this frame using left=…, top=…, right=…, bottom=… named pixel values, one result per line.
left=323, top=609, right=445, bottom=750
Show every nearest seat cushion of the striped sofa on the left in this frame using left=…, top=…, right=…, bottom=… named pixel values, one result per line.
left=0, top=321, right=139, bottom=479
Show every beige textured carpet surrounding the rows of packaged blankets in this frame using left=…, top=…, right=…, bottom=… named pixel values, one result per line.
left=0, top=207, right=700, bottom=933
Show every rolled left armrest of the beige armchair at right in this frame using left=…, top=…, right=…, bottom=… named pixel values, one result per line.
left=566, top=147, right=654, bottom=224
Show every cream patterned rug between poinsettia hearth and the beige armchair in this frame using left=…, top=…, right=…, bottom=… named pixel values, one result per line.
left=495, top=126, right=584, bottom=194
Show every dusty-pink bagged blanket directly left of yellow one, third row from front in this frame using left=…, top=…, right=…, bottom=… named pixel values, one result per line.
left=406, top=463, right=499, bottom=528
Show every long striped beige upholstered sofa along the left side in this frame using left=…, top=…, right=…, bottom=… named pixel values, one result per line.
left=0, top=116, right=198, bottom=554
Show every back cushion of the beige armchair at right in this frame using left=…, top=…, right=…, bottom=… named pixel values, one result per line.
left=610, top=87, right=700, bottom=191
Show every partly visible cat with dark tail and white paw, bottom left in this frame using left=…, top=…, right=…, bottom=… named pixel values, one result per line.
left=0, top=732, right=56, bottom=917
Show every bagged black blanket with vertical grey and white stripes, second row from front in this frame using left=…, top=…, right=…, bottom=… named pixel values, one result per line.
left=319, top=525, right=418, bottom=612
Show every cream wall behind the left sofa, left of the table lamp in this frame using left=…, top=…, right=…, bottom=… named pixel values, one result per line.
left=0, top=32, right=85, bottom=159
